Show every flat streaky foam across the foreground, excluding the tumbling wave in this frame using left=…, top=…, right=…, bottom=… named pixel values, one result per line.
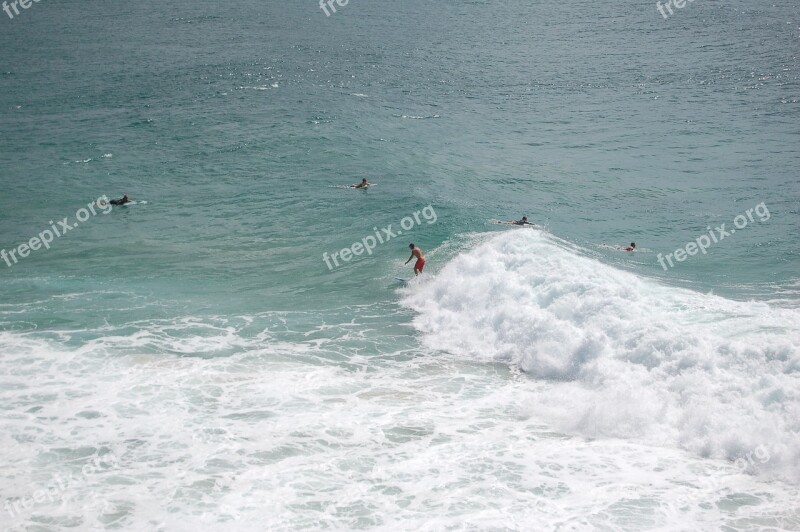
left=0, top=302, right=800, bottom=532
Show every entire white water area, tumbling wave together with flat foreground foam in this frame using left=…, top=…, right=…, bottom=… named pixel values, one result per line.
left=0, top=229, right=800, bottom=530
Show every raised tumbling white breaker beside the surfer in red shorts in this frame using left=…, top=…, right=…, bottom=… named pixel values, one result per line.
left=404, top=230, right=800, bottom=482
